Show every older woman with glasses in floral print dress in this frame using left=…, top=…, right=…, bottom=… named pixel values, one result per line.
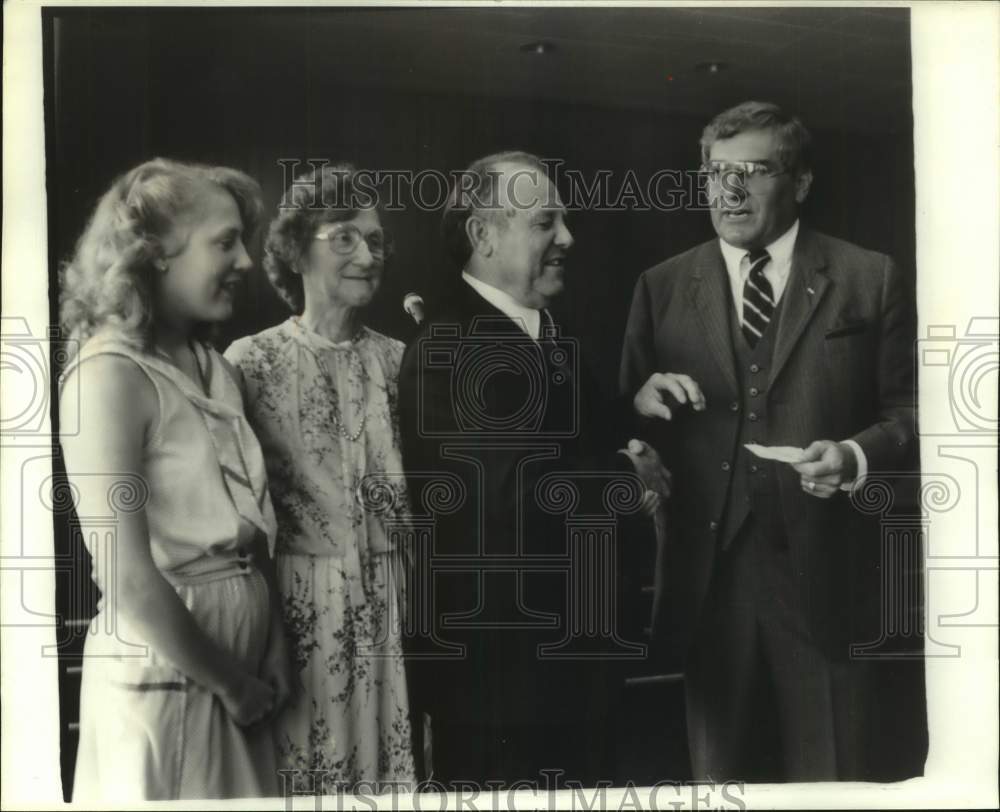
left=226, top=167, right=414, bottom=794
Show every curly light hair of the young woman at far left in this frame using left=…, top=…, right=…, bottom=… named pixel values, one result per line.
left=59, top=158, right=263, bottom=353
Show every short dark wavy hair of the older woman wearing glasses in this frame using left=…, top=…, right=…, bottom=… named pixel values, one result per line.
left=264, top=163, right=377, bottom=313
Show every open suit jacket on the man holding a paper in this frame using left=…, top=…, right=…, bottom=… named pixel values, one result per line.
left=620, top=227, right=915, bottom=656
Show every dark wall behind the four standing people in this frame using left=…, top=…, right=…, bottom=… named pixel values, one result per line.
left=46, top=9, right=915, bottom=400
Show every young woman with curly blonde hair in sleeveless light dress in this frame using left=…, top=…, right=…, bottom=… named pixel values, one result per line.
left=60, top=159, right=290, bottom=802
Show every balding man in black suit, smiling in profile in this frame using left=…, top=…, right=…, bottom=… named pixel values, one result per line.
left=399, top=153, right=665, bottom=787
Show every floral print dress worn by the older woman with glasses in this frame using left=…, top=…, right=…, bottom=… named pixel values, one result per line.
left=226, top=317, right=415, bottom=794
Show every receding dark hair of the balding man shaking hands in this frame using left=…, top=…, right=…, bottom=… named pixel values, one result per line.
left=441, top=151, right=548, bottom=268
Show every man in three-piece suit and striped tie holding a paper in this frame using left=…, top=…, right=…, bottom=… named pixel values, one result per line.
left=621, top=102, right=915, bottom=781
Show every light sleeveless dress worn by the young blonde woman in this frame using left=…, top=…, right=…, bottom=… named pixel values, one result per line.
left=63, top=335, right=278, bottom=802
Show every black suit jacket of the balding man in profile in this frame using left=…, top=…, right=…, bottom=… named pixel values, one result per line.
left=399, top=283, right=627, bottom=726
